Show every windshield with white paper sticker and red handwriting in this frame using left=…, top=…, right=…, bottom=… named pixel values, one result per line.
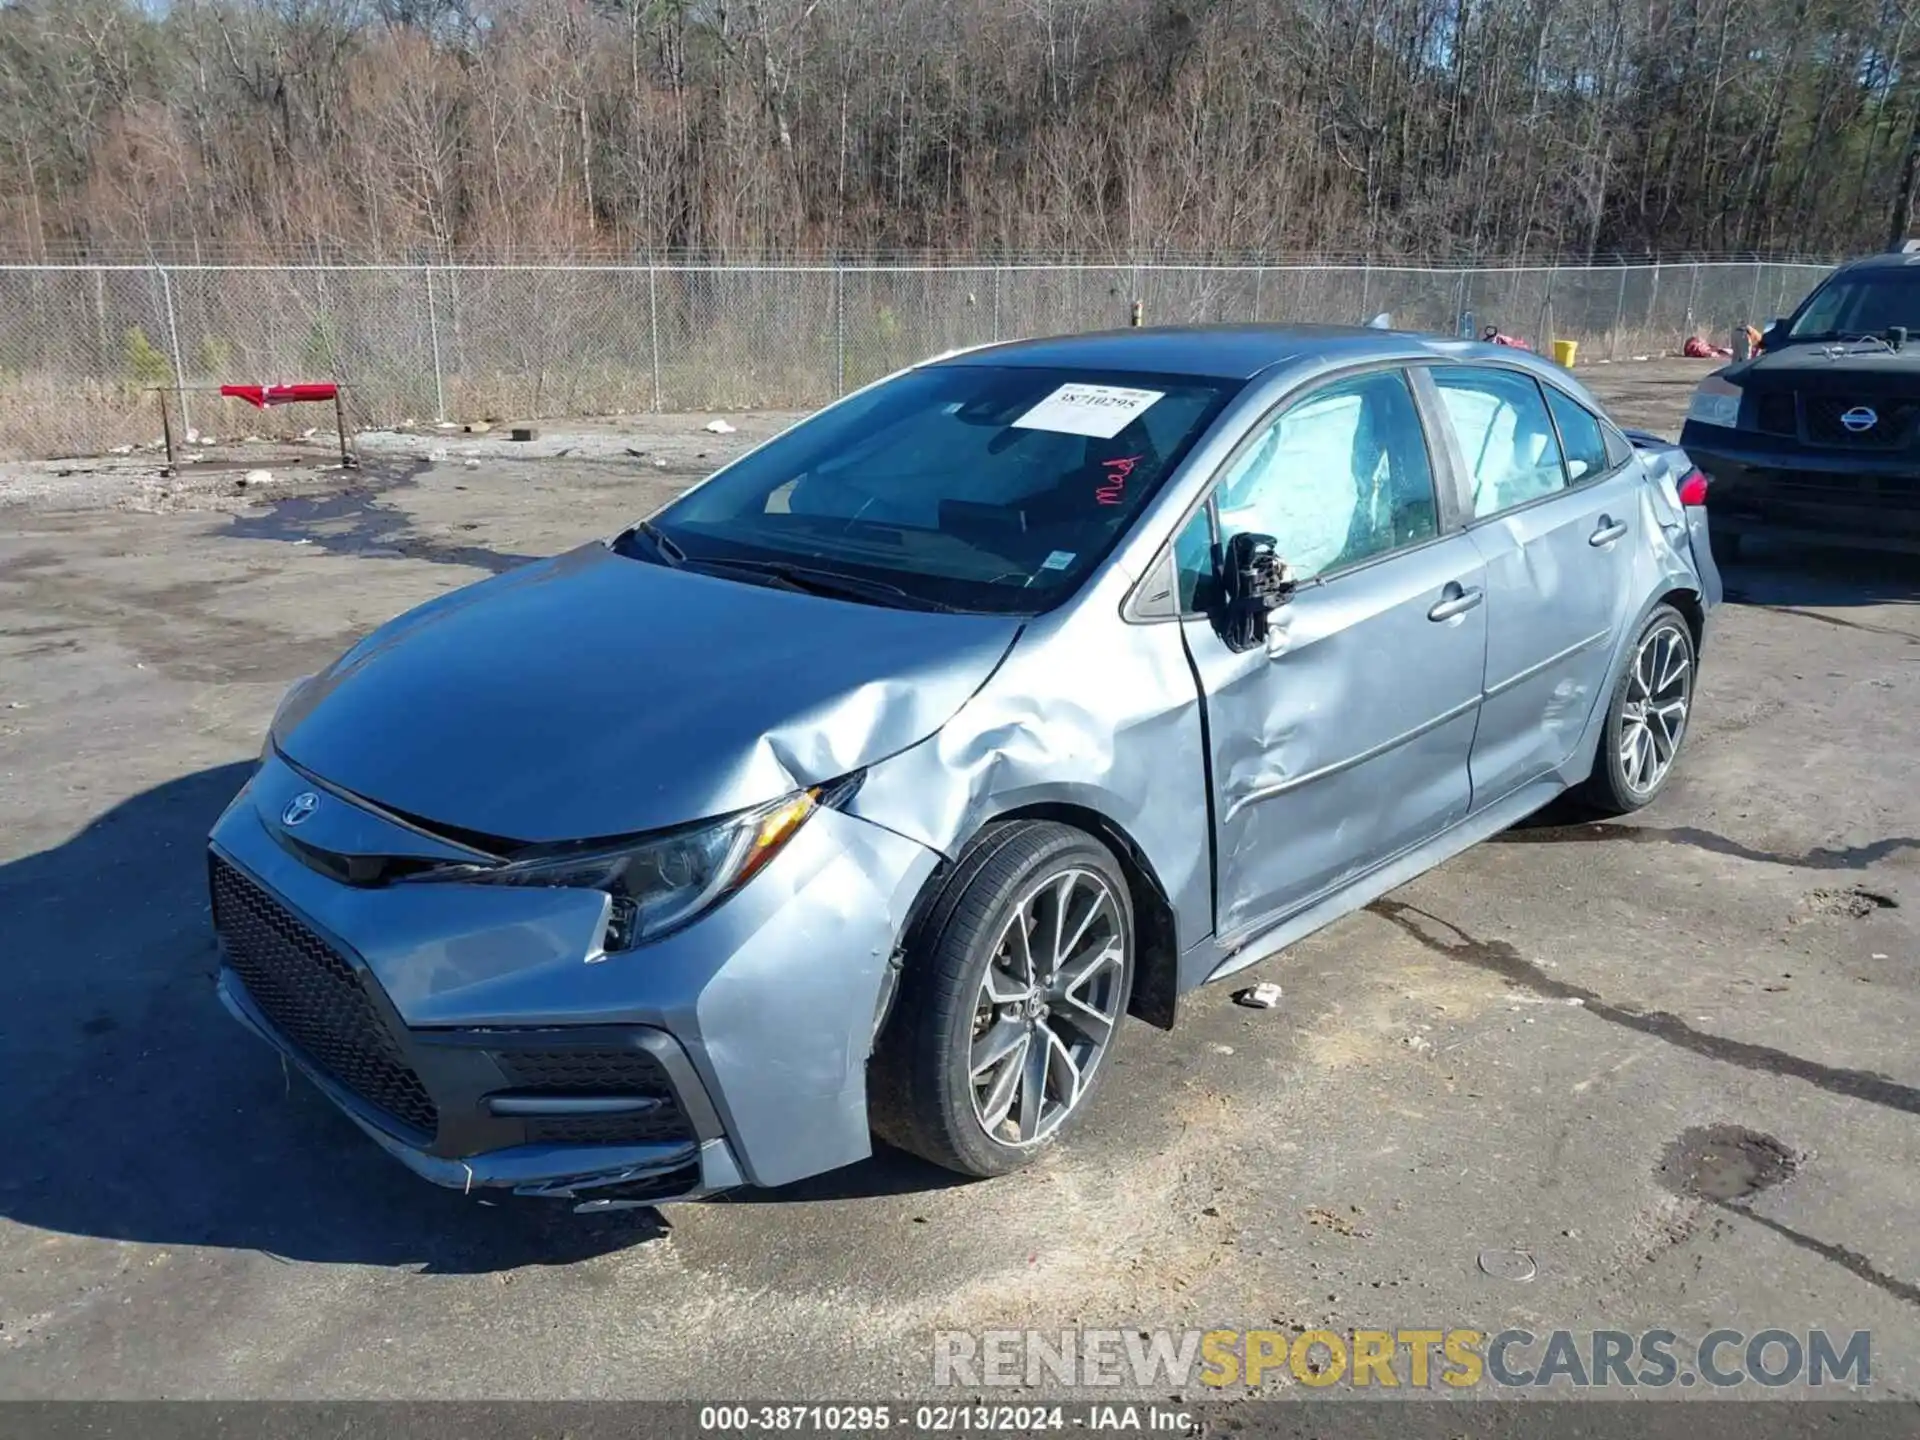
left=622, top=365, right=1240, bottom=614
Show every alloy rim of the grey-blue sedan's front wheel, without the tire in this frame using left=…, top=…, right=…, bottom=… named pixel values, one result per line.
left=968, top=870, right=1127, bottom=1146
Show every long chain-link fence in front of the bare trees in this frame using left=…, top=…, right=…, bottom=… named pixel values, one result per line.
left=0, top=261, right=1824, bottom=457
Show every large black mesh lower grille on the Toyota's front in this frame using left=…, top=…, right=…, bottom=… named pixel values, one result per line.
left=211, top=854, right=438, bottom=1135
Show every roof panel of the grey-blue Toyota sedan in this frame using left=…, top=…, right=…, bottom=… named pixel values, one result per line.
left=927, top=324, right=1565, bottom=384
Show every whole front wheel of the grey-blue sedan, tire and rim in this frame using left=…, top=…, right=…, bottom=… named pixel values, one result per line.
left=868, top=820, right=1135, bottom=1177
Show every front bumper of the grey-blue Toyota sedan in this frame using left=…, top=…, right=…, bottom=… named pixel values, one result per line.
left=209, top=758, right=939, bottom=1202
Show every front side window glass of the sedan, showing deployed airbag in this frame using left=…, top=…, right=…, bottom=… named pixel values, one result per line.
left=1215, top=371, right=1438, bottom=580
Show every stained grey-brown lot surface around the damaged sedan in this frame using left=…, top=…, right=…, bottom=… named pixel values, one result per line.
left=0, top=361, right=1920, bottom=1398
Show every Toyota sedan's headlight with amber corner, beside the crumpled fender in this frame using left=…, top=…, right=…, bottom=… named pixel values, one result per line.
left=409, top=789, right=820, bottom=954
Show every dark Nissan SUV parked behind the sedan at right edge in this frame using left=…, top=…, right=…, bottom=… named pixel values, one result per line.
left=1680, top=242, right=1920, bottom=559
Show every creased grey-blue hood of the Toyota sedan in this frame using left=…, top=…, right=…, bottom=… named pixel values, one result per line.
left=275, top=543, right=1021, bottom=843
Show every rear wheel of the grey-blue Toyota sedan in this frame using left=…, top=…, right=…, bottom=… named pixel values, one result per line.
left=1582, top=605, right=1697, bottom=816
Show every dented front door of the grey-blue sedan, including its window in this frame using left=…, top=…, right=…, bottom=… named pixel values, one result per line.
left=1179, top=369, right=1486, bottom=943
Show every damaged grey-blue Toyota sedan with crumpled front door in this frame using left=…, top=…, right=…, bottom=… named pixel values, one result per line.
left=209, top=326, right=1720, bottom=1206
